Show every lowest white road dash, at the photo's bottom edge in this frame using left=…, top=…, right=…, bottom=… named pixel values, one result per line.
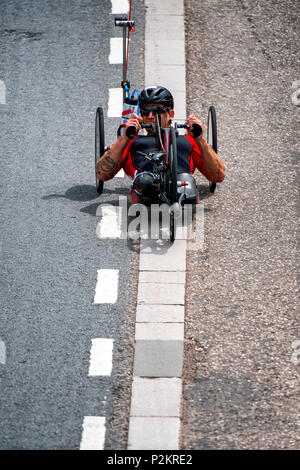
left=80, top=416, right=105, bottom=450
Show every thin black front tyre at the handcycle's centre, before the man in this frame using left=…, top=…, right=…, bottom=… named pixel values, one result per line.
left=169, top=127, right=177, bottom=242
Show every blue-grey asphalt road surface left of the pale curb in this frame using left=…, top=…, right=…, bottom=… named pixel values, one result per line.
left=0, top=0, right=144, bottom=449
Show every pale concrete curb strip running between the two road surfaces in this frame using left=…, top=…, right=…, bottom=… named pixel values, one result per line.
left=127, top=0, right=187, bottom=450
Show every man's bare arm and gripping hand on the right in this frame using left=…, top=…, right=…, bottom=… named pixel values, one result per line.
left=187, top=114, right=225, bottom=183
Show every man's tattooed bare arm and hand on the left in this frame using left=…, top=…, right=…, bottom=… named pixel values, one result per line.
left=96, top=114, right=141, bottom=181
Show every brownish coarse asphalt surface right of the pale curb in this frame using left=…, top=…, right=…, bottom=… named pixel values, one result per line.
left=182, top=0, right=300, bottom=449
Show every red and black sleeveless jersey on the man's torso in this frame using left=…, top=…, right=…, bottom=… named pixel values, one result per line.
left=122, top=134, right=204, bottom=178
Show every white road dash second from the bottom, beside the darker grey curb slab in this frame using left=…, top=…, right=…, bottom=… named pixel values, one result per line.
left=89, top=338, right=114, bottom=376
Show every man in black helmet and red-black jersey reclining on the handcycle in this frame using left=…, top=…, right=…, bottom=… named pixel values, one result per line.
left=96, top=86, right=225, bottom=239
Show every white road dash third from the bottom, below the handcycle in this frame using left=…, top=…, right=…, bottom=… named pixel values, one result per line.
left=94, top=269, right=119, bottom=304
